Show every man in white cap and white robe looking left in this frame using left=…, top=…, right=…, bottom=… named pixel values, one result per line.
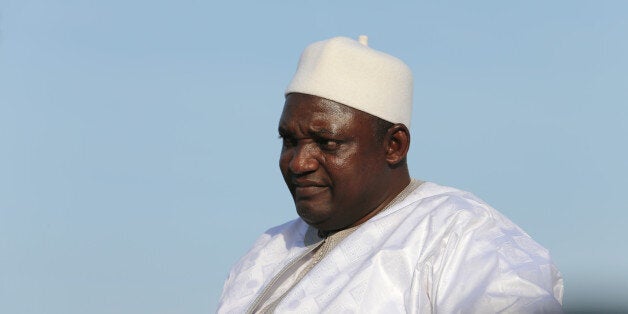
left=218, top=36, right=563, bottom=313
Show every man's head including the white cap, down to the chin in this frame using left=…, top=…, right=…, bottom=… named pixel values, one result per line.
left=279, top=37, right=412, bottom=231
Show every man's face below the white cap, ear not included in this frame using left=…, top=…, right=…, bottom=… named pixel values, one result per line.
left=279, top=93, right=388, bottom=231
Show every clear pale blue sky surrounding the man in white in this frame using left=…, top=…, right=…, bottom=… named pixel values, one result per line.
left=0, top=0, right=628, bottom=314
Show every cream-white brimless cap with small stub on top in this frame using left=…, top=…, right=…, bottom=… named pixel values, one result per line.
left=286, top=36, right=412, bottom=128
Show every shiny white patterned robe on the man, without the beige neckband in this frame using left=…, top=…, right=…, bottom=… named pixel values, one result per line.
left=218, top=182, right=563, bottom=313
